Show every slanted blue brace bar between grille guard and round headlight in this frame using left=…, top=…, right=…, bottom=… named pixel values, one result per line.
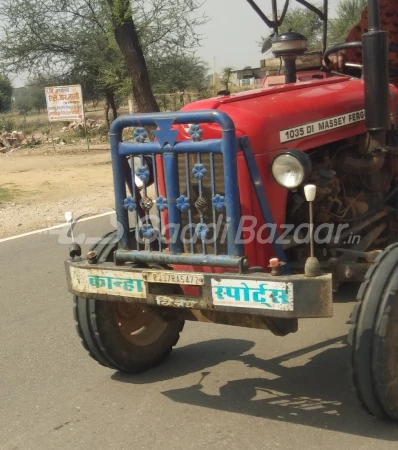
left=240, top=136, right=290, bottom=273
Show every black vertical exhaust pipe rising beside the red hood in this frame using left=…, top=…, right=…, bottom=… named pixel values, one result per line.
left=362, top=0, right=390, bottom=145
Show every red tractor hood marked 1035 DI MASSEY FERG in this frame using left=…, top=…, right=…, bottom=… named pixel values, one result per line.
left=181, top=76, right=397, bottom=153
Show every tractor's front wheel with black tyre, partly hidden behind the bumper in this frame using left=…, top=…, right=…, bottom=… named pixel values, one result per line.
left=74, top=232, right=184, bottom=373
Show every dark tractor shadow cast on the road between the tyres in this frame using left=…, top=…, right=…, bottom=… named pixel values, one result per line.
left=113, top=336, right=398, bottom=441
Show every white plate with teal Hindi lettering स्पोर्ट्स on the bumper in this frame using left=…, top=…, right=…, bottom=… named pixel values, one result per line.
left=211, top=278, right=294, bottom=311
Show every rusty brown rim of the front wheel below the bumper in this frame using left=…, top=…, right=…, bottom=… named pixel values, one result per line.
left=115, top=303, right=167, bottom=347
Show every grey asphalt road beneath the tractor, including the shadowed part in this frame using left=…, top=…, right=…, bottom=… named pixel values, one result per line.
left=0, top=218, right=398, bottom=450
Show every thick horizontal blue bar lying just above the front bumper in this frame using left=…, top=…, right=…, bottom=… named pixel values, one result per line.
left=115, top=250, right=247, bottom=272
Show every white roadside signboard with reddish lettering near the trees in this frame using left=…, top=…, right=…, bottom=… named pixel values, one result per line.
left=45, top=85, right=84, bottom=122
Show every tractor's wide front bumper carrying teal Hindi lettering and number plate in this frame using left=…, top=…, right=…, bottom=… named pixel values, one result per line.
left=65, top=260, right=332, bottom=319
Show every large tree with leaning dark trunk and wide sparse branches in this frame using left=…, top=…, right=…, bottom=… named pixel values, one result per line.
left=0, top=0, right=206, bottom=116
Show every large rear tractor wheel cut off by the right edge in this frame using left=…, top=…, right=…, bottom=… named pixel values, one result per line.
left=350, top=244, right=398, bottom=420
